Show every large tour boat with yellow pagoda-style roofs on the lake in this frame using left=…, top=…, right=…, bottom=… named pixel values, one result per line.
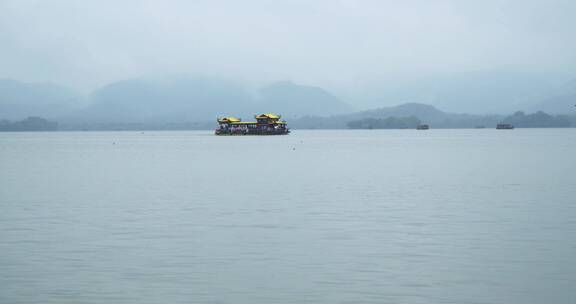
left=214, top=113, right=290, bottom=135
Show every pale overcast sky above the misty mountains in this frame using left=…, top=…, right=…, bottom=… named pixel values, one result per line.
left=0, top=0, right=576, bottom=89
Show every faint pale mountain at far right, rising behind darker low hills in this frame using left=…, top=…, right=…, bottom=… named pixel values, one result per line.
left=352, top=70, right=568, bottom=114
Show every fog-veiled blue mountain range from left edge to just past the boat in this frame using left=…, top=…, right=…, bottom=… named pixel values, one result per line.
left=0, top=76, right=353, bottom=123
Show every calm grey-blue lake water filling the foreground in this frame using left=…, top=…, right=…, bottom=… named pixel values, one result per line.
left=0, top=129, right=576, bottom=304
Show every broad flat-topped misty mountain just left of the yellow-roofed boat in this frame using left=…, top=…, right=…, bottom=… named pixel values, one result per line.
left=78, top=77, right=254, bottom=123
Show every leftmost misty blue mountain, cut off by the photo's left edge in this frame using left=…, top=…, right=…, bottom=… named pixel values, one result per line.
left=0, top=79, right=82, bottom=119
